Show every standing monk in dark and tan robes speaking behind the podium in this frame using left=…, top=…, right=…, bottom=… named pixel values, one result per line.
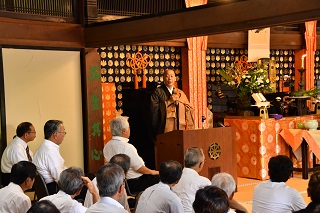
left=151, top=69, right=194, bottom=135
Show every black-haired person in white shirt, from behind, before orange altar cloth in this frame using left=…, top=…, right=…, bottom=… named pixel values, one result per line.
left=252, top=155, right=306, bottom=213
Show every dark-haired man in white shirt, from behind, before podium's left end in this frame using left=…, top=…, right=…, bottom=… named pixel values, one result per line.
left=135, top=161, right=184, bottom=213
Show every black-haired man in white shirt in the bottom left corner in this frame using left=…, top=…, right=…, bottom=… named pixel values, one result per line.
left=0, top=161, right=37, bottom=213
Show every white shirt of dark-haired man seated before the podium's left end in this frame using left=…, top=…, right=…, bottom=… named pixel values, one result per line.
left=136, top=182, right=184, bottom=213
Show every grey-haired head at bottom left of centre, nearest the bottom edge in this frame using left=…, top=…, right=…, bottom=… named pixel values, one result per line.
left=96, top=163, right=125, bottom=197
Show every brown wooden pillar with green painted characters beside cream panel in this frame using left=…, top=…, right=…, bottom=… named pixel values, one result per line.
left=81, top=48, right=104, bottom=173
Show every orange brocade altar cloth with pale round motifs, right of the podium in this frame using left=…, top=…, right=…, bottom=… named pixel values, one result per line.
left=224, top=115, right=320, bottom=180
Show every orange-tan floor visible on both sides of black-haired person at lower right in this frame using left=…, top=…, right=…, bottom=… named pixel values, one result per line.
left=234, top=173, right=310, bottom=212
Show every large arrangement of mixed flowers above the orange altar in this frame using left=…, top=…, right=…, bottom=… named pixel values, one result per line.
left=219, top=62, right=271, bottom=97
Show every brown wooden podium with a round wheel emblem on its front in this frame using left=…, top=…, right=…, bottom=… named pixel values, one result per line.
left=156, top=127, right=237, bottom=181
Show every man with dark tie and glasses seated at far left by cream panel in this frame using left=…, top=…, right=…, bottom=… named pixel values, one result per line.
left=1, top=122, right=36, bottom=186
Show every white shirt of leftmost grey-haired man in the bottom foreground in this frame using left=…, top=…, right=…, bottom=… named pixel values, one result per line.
left=41, top=190, right=87, bottom=213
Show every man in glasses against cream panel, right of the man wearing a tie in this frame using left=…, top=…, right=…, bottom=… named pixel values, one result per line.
left=33, top=120, right=67, bottom=195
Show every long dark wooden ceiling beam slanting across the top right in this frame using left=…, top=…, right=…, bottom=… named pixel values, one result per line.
left=84, top=0, right=320, bottom=47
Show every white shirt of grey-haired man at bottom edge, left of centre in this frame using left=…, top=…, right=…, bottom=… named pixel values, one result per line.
left=86, top=197, right=128, bottom=213
